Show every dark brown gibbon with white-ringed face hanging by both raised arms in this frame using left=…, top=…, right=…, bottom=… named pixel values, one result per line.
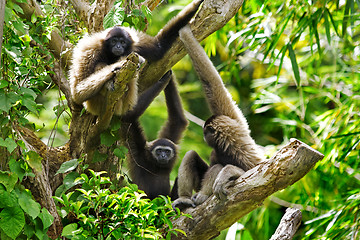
left=122, top=71, right=188, bottom=199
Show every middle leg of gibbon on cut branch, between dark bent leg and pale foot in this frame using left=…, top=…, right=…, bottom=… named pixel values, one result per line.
left=192, top=164, right=223, bottom=205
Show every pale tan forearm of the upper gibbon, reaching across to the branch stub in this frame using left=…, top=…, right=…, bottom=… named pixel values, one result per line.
left=72, top=61, right=123, bottom=104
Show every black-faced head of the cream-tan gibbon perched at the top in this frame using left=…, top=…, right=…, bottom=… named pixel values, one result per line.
left=104, top=27, right=134, bottom=59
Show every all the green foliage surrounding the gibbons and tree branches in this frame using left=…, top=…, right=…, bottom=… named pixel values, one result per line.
left=0, top=0, right=360, bottom=240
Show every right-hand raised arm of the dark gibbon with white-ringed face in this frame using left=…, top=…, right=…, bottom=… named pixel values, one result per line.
left=159, top=78, right=189, bottom=144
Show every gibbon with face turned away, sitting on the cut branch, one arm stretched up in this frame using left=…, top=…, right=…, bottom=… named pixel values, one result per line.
left=173, top=26, right=263, bottom=209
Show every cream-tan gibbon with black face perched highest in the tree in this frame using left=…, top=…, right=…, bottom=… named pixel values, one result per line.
left=70, top=0, right=203, bottom=115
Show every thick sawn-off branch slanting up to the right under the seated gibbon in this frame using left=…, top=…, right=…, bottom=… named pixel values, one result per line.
left=173, top=139, right=323, bottom=239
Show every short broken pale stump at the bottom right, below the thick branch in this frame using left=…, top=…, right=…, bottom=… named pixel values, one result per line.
left=270, top=208, right=302, bottom=240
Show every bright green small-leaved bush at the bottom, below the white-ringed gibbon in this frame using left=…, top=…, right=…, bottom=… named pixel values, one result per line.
left=54, top=170, right=188, bottom=239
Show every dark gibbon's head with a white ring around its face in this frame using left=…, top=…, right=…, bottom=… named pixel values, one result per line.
left=149, top=138, right=177, bottom=168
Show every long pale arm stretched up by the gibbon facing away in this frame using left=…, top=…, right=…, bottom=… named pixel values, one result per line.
left=179, top=25, right=247, bottom=125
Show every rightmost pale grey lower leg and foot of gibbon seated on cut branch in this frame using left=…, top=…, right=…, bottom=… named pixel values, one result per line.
left=213, top=165, right=245, bottom=201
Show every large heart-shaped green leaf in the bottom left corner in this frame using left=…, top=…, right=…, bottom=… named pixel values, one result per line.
left=0, top=207, right=25, bottom=239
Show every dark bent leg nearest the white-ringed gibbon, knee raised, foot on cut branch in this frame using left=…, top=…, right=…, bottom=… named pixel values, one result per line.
left=173, top=150, right=209, bottom=210
